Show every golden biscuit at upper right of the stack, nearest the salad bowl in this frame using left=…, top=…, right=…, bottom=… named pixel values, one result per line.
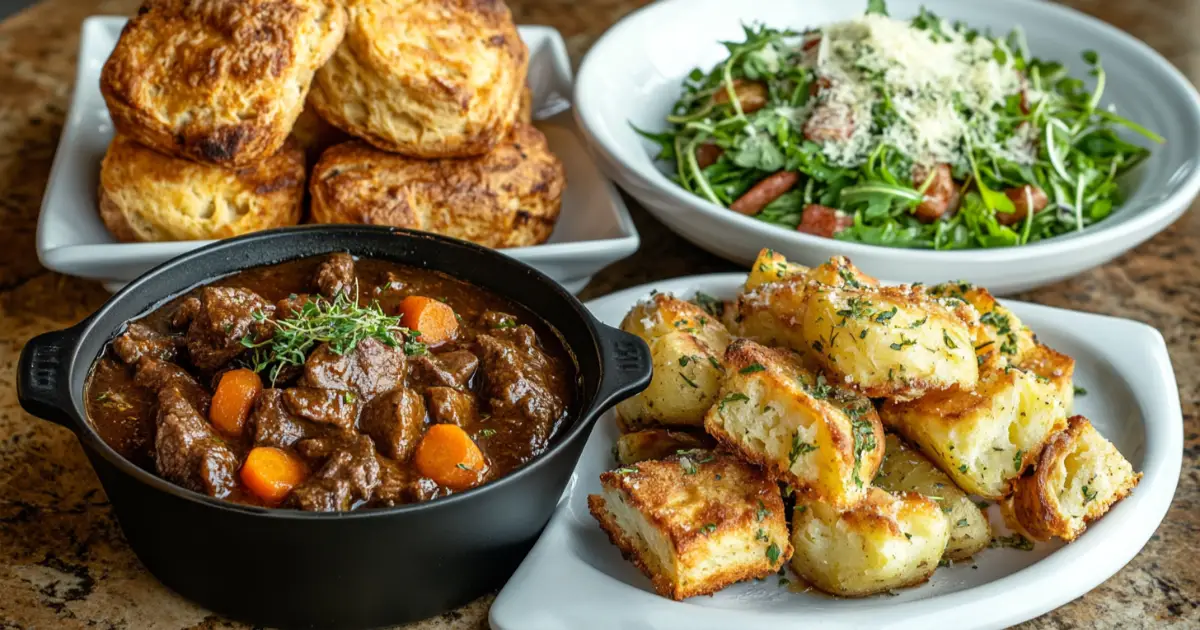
left=310, top=0, right=529, bottom=158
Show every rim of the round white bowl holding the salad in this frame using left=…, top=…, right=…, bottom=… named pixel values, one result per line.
left=574, top=0, right=1200, bottom=264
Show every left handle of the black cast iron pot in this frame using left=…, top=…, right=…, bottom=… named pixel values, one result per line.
left=17, top=328, right=78, bottom=431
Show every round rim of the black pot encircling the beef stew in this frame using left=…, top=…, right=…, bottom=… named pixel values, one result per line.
left=64, top=224, right=616, bottom=521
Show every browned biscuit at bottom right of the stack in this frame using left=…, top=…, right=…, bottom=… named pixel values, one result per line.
left=310, top=124, right=565, bottom=247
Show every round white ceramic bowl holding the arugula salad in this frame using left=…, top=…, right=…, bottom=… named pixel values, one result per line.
left=575, top=0, right=1200, bottom=294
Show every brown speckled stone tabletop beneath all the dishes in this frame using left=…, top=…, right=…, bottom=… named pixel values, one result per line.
left=0, top=0, right=1200, bottom=630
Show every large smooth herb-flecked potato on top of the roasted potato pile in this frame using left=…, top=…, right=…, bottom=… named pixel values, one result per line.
left=803, top=287, right=979, bottom=400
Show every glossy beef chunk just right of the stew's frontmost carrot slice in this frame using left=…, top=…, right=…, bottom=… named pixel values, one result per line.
left=288, top=433, right=379, bottom=512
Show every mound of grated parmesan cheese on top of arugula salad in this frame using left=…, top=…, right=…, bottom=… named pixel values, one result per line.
left=804, top=14, right=1037, bottom=168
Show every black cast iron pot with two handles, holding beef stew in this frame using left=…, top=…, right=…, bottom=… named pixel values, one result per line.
left=17, top=226, right=650, bottom=628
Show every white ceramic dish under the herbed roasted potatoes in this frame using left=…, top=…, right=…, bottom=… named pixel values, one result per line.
left=491, top=274, right=1183, bottom=630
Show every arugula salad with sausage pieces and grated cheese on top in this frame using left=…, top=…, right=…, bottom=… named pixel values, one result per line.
left=635, top=0, right=1164, bottom=250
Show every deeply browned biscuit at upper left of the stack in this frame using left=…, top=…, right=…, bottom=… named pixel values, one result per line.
left=101, top=0, right=346, bottom=167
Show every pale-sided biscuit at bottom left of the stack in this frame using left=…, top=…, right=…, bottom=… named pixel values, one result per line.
left=100, top=134, right=305, bottom=241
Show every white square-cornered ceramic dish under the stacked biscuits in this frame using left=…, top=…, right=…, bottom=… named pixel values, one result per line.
left=37, top=16, right=638, bottom=290
